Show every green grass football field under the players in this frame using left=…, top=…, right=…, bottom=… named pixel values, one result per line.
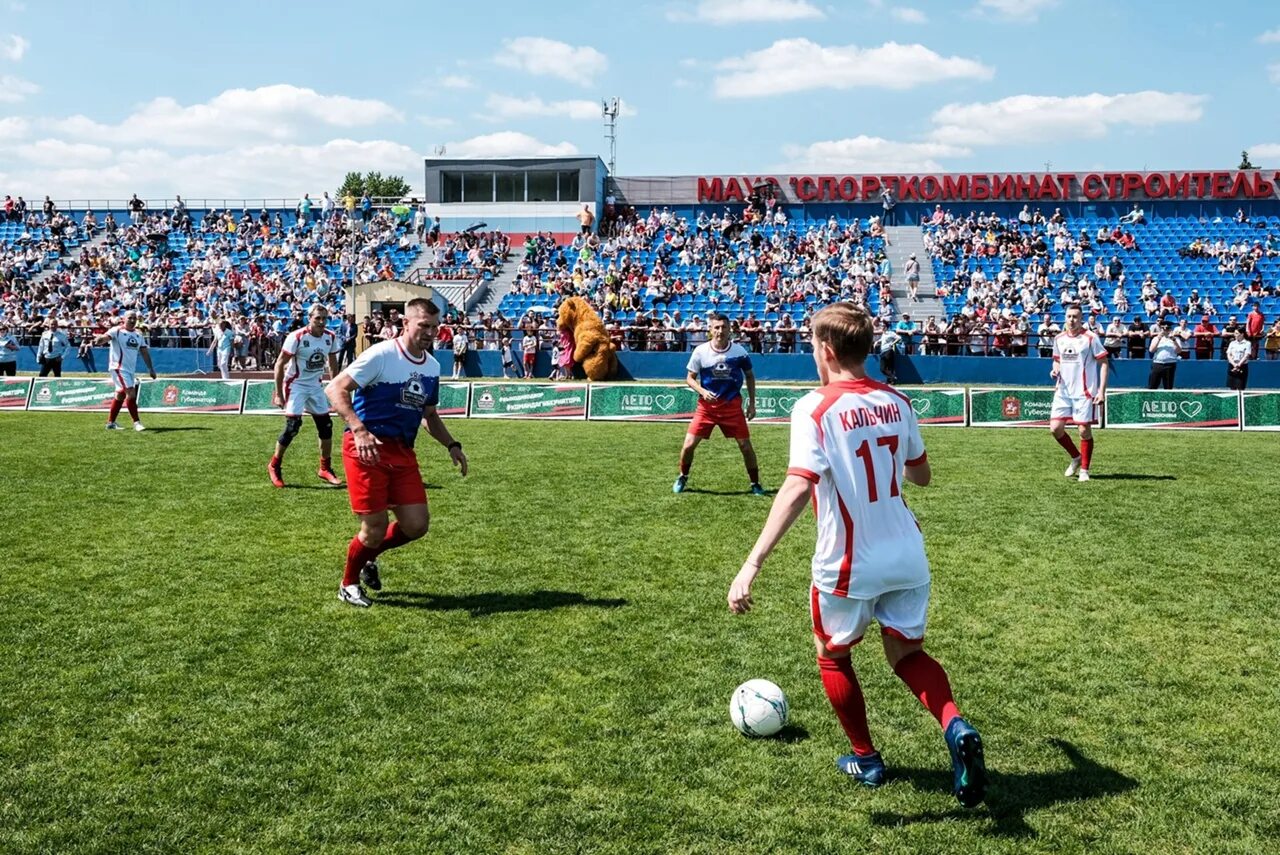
left=0, top=413, right=1280, bottom=855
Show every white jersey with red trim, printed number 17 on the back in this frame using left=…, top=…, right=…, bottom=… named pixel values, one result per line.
left=787, top=379, right=929, bottom=599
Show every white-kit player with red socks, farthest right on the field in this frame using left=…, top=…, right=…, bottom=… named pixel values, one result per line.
left=1048, top=306, right=1111, bottom=481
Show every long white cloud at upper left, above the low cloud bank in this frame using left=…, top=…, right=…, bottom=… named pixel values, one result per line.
left=52, top=83, right=403, bottom=147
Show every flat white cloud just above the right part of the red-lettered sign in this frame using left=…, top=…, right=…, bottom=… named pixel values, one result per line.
left=929, top=91, right=1208, bottom=146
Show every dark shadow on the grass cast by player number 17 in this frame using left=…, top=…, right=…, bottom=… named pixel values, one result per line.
left=872, top=740, right=1138, bottom=837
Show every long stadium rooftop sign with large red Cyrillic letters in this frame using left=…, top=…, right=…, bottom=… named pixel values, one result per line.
left=698, top=170, right=1280, bottom=202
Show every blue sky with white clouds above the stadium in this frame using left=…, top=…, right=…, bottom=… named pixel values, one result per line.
left=0, top=0, right=1280, bottom=198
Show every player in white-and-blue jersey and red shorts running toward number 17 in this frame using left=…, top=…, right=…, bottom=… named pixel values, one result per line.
left=325, top=298, right=467, bottom=607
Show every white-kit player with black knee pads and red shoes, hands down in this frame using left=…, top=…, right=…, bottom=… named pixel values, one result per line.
left=266, top=303, right=342, bottom=486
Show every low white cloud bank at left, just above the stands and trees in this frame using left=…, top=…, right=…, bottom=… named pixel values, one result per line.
left=0, top=140, right=422, bottom=200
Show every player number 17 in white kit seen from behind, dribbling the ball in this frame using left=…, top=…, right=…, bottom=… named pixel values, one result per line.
left=728, top=303, right=987, bottom=808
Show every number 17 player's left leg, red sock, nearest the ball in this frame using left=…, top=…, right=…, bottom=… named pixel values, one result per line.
left=809, top=587, right=884, bottom=787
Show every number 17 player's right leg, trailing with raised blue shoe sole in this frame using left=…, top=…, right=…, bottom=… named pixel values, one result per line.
left=874, top=584, right=987, bottom=808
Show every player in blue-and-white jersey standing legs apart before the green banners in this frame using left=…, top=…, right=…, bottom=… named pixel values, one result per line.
left=671, top=312, right=764, bottom=495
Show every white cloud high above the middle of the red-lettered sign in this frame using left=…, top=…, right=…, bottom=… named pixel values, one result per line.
left=714, top=38, right=995, bottom=99
